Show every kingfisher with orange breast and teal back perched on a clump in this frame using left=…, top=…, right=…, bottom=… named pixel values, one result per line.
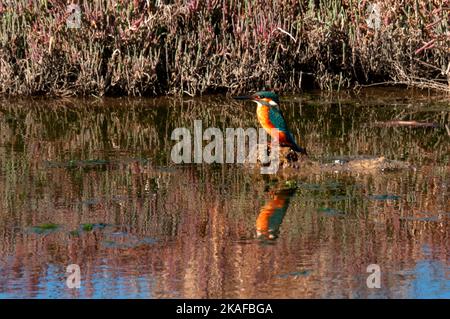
left=235, top=91, right=308, bottom=155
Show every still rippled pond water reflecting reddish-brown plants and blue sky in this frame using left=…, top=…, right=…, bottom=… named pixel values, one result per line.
left=0, top=89, right=450, bottom=298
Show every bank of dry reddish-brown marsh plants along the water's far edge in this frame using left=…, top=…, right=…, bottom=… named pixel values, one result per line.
left=0, top=0, right=450, bottom=96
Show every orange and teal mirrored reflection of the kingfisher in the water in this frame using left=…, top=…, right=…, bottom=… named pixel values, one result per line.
left=256, top=188, right=295, bottom=240
